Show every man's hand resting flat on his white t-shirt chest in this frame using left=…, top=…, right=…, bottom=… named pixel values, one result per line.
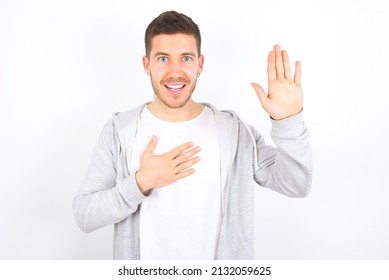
left=135, top=136, right=201, bottom=193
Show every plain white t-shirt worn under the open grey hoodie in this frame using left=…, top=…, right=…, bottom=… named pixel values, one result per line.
left=129, top=106, right=222, bottom=259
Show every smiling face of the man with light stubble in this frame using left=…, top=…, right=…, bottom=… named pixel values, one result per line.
left=143, top=34, right=204, bottom=109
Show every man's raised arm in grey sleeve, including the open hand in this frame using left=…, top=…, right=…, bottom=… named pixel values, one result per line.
left=252, top=45, right=312, bottom=197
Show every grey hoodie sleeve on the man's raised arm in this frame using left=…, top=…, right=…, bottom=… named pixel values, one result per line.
left=254, top=112, right=312, bottom=197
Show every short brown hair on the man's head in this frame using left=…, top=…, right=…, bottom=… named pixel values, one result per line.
left=145, top=11, right=201, bottom=57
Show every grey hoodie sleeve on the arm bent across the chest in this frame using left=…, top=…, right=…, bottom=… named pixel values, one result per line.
left=73, top=121, right=144, bottom=232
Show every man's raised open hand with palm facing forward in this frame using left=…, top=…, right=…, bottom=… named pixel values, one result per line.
left=251, top=45, right=303, bottom=120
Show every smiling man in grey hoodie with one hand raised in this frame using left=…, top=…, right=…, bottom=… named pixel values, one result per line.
left=73, top=11, right=312, bottom=259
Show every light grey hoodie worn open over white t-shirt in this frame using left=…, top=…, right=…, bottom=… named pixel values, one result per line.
left=73, top=104, right=312, bottom=259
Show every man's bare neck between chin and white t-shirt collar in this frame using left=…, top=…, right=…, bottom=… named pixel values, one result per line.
left=147, top=99, right=204, bottom=122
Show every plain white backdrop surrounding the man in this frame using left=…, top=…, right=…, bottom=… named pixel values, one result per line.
left=0, top=0, right=389, bottom=259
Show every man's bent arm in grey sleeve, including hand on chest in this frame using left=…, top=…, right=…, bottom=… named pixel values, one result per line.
left=73, top=122, right=200, bottom=232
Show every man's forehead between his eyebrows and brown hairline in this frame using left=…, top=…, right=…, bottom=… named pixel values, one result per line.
left=151, top=33, right=197, bottom=55
